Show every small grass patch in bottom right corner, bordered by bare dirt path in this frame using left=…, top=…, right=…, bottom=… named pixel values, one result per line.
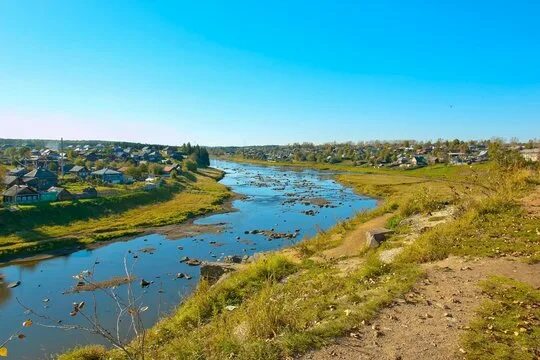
left=462, top=277, right=540, bottom=360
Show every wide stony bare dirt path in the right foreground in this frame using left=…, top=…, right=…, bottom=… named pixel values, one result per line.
left=301, top=257, right=540, bottom=360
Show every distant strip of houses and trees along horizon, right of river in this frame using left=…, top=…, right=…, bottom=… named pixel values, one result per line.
left=209, top=140, right=540, bottom=168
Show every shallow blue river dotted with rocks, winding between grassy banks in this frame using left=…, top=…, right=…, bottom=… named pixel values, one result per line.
left=0, top=161, right=376, bottom=359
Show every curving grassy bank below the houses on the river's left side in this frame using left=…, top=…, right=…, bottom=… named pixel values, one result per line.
left=0, top=169, right=231, bottom=261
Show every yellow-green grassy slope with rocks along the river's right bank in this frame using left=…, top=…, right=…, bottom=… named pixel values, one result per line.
left=61, top=160, right=540, bottom=360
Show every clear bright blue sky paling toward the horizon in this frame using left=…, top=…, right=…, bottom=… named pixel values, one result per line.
left=0, top=0, right=540, bottom=145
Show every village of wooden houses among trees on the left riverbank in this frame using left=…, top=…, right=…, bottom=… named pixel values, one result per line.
left=0, top=140, right=210, bottom=206
